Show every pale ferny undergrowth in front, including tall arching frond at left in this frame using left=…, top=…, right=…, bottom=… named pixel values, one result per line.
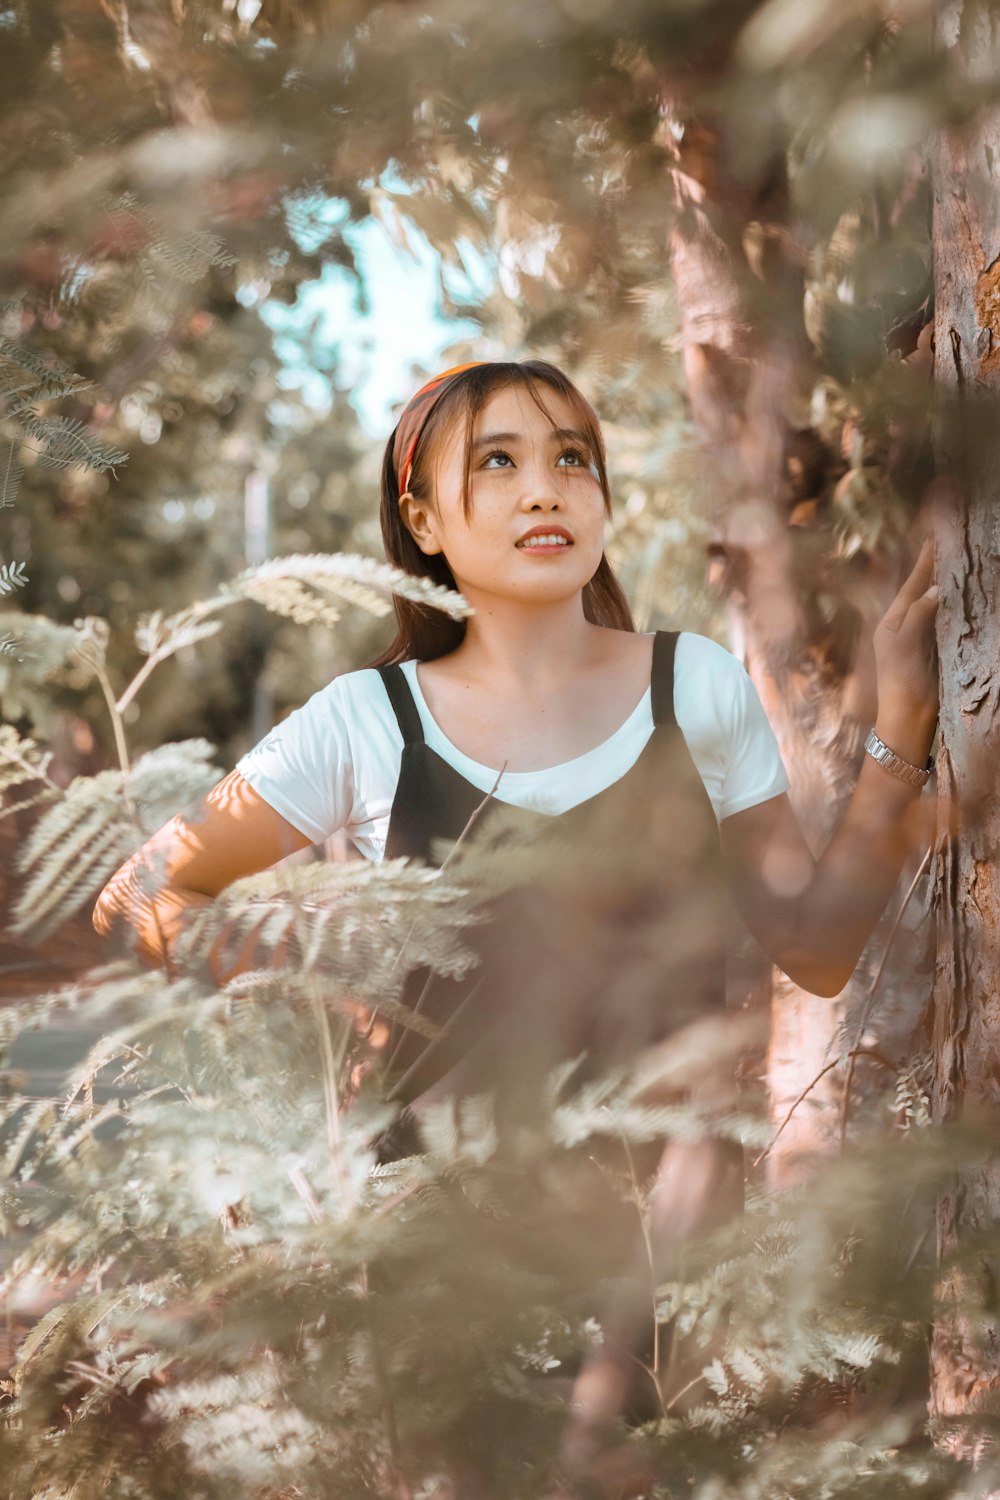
left=0, top=573, right=993, bottom=1500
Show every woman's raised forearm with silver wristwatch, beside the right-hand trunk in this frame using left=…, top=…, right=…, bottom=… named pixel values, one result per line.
left=781, top=710, right=937, bottom=995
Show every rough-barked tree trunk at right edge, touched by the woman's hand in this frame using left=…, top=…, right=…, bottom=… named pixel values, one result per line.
left=930, top=0, right=1000, bottom=1458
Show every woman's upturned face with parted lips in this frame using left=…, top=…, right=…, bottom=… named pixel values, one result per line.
left=400, top=386, right=606, bottom=603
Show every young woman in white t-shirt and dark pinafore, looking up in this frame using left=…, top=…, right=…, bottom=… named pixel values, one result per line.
left=94, top=360, right=937, bottom=1488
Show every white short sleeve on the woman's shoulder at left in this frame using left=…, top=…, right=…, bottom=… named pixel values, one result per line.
left=235, top=678, right=355, bottom=843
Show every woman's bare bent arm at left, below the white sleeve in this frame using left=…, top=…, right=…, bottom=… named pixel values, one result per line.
left=93, top=771, right=313, bottom=981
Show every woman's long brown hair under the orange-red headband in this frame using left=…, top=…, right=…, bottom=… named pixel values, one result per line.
left=369, top=360, right=636, bottom=666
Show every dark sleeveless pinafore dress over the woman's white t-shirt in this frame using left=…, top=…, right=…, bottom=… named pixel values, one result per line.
left=371, top=630, right=732, bottom=1160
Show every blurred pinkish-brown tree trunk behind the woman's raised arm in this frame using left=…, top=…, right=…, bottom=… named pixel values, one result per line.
left=664, top=70, right=930, bottom=1185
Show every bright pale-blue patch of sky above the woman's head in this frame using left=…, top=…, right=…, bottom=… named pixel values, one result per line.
left=261, top=200, right=492, bottom=438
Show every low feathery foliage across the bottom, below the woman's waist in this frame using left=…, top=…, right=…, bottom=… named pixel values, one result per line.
left=0, top=894, right=987, bottom=1500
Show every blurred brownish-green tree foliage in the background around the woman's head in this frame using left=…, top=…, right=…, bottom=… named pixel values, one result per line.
left=0, top=0, right=971, bottom=749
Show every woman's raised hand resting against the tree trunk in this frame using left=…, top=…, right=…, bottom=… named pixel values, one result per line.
left=873, top=537, right=940, bottom=729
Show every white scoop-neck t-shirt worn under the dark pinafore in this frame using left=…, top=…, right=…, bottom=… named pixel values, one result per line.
left=235, top=630, right=789, bottom=860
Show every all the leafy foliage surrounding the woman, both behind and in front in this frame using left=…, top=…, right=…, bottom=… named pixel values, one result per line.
left=0, top=0, right=1000, bottom=1500
